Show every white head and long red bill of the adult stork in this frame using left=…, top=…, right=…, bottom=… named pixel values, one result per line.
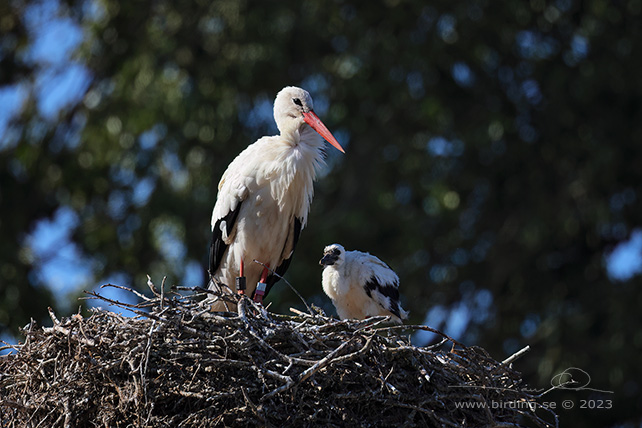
left=274, top=86, right=345, bottom=153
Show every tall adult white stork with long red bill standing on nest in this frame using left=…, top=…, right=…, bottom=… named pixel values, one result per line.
left=209, top=86, right=344, bottom=310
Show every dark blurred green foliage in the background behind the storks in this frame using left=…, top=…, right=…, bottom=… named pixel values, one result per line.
left=0, top=0, right=642, bottom=426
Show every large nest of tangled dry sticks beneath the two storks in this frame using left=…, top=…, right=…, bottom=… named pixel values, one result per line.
left=0, top=281, right=557, bottom=428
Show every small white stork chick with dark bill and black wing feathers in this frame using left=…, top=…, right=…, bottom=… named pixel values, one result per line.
left=319, top=244, right=408, bottom=323
